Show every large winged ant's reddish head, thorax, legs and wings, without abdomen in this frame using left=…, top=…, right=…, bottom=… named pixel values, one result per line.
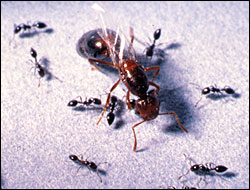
left=88, top=4, right=188, bottom=151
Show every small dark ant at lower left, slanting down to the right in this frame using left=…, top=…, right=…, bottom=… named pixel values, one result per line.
left=69, top=154, right=107, bottom=183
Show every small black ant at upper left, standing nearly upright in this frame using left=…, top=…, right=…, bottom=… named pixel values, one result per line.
left=30, top=48, right=62, bottom=87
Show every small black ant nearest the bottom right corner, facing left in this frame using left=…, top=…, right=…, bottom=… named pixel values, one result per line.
left=178, top=154, right=228, bottom=184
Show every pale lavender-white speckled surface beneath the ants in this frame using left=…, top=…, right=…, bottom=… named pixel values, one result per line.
left=1, top=2, right=249, bottom=188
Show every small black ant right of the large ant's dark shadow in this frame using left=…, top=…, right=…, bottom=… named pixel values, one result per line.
left=190, top=83, right=236, bottom=107
